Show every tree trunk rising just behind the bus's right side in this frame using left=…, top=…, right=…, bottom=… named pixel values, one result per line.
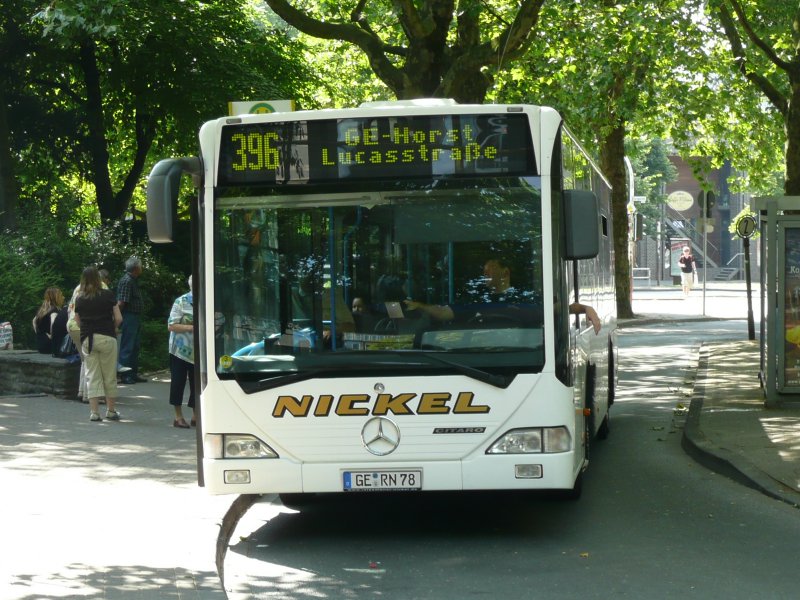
left=600, top=123, right=634, bottom=319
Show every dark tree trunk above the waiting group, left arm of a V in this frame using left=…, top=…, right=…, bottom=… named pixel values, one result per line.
left=80, top=40, right=117, bottom=221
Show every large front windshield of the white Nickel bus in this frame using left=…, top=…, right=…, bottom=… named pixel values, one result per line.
left=213, top=176, right=544, bottom=380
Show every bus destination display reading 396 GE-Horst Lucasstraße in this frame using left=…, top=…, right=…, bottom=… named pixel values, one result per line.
left=218, top=114, right=536, bottom=185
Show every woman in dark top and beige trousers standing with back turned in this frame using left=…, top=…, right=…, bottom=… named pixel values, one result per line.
left=75, top=267, right=122, bottom=421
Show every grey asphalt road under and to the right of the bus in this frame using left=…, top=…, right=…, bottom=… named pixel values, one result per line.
left=225, top=320, right=800, bottom=600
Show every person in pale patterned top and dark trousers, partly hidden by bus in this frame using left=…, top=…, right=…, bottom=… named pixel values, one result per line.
left=167, top=275, right=197, bottom=429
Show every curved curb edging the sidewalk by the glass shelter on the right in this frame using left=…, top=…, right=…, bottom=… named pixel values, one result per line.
left=681, top=345, right=800, bottom=508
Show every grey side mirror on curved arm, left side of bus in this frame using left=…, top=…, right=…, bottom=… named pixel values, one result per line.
left=147, top=157, right=200, bottom=243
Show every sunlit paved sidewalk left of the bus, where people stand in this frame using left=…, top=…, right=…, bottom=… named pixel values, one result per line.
left=0, top=378, right=232, bottom=600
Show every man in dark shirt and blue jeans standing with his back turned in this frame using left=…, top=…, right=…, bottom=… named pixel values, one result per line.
left=117, top=256, right=147, bottom=384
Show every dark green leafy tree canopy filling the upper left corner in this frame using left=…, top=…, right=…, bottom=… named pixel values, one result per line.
left=0, top=0, right=314, bottom=221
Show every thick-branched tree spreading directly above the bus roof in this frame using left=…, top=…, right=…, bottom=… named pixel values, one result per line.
left=266, top=0, right=544, bottom=103
